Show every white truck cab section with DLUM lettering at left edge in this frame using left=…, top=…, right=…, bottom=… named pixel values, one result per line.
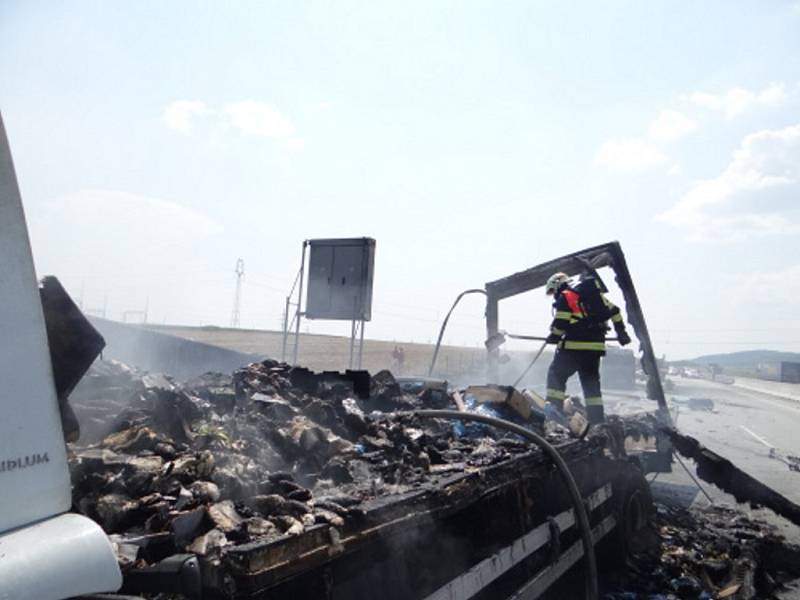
left=0, top=111, right=122, bottom=600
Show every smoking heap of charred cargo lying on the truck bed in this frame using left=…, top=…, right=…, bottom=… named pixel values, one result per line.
left=70, top=361, right=566, bottom=569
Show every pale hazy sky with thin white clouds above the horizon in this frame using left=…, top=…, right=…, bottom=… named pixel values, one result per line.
left=0, top=0, right=800, bottom=358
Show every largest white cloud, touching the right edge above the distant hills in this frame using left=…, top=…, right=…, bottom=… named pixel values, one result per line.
left=657, top=124, right=800, bottom=241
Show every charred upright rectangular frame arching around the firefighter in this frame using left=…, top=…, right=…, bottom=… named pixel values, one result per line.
left=485, top=241, right=673, bottom=473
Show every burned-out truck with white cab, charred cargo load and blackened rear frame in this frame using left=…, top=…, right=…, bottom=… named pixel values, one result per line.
left=0, top=103, right=796, bottom=600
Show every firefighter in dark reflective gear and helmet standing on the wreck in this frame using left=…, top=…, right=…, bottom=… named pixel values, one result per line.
left=545, top=273, right=631, bottom=425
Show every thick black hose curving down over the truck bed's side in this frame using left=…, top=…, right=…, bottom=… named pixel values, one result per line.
left=394, top=410, right=599, bottom=600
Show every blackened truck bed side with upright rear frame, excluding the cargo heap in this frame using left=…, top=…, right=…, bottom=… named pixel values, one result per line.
left=69, top=240, right=671, bottom=600
